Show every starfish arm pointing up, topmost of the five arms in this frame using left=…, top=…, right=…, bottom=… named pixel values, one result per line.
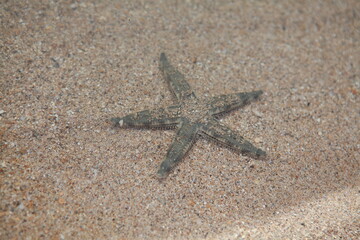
left=159, top=53, right=195, bottom=101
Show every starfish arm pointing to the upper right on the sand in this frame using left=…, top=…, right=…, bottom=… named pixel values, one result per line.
left=209, top=90, right=263, bottom=115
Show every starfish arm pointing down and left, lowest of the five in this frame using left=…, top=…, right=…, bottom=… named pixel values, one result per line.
left=158, top=120, right=199, bottom=178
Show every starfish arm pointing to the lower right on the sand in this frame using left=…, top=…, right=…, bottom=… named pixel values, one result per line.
left=199, top=119, right=266, bottom=158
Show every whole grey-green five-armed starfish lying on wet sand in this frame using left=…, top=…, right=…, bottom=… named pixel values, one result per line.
left=111, top=53, right=266, bottom=178
